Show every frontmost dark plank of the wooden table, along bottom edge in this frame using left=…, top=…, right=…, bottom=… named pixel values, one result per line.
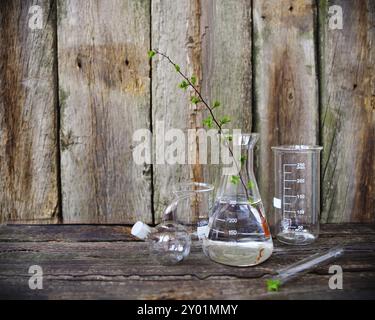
left=0, top=273, right=375, bottom=300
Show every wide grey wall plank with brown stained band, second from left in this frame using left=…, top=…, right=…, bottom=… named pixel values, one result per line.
left=57, top=0, right=152, bottom=223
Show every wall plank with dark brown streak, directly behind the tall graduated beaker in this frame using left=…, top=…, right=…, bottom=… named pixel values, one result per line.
left=253, top=0, right=319, bottom=225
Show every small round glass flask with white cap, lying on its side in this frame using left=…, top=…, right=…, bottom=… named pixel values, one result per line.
left=131, top=221, right=191, bottom=265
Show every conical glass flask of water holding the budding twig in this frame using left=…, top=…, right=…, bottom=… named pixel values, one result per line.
left=203, top=133, right=273, bottom=267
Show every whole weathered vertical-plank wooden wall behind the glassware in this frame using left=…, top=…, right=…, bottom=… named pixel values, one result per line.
left=0, top=0, right=375, bottom=223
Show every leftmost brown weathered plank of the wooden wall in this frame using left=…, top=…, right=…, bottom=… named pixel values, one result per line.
left=0, top=0, right=59, bottom=223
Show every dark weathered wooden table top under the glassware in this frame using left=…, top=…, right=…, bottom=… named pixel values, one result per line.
left=0, top=224, right=375, bottom=299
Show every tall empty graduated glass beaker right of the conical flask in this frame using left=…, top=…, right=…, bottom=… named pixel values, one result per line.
left=272, top=145, right=323, bottom=245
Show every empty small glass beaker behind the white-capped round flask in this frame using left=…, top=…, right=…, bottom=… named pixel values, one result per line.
left=173, top=182, right=214, bottom=240
